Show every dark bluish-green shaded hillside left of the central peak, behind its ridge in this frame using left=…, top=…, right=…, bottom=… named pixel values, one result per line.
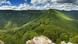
left=0, top=10, right=43, bottom=27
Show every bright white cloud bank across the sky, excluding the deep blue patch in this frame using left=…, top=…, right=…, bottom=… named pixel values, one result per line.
left=0, top=0, right=78, bottom=11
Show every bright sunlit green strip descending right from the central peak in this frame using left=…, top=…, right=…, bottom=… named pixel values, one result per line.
left=47, top=9, right=74, bottom=21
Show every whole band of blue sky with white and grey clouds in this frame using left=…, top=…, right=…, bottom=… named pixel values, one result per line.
left=0, top=0, right=78, bottom=11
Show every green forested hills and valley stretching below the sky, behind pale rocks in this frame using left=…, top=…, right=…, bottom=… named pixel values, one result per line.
left=0, top=9, right=78, bottom=44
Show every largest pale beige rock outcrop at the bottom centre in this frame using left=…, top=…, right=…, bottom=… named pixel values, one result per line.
left=26, top=36, right=54, bottom=44
